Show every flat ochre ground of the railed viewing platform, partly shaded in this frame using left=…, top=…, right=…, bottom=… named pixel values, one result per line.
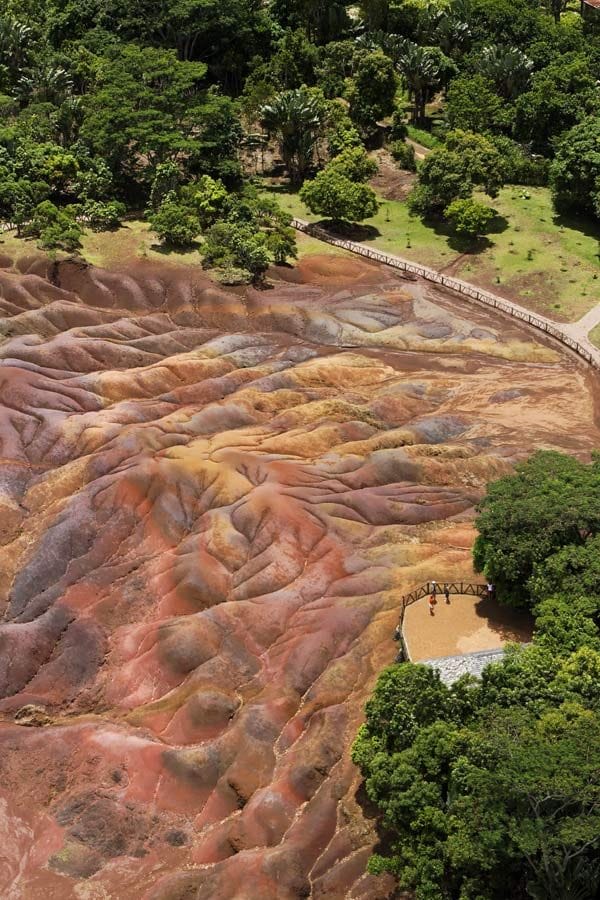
left=403, top=594, right=532, bottom=662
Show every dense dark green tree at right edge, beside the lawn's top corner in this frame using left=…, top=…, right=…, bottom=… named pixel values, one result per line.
left=550, top=116, right=600, bottom=218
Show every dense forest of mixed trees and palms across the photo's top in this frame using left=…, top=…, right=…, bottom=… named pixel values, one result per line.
left=0, top=0, right=600, bottom=281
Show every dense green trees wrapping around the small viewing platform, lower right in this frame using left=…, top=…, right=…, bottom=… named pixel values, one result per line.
left=353, top=452, right=600, bottom=900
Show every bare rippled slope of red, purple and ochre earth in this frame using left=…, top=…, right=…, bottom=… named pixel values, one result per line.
left=0, top=251, right=600, bottom=900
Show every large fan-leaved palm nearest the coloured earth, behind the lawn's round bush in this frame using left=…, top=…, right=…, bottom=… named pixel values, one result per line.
left=260, top=88, right=324, bottom=184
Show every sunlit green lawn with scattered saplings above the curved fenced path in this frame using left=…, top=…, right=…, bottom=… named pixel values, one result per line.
left=268, top=186, right=600, bottom=321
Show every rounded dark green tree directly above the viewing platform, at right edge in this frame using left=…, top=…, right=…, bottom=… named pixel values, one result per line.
left=473, top=451, right=600, bottom=606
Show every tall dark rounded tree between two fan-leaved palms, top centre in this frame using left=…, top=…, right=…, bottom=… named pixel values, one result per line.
left=346, top=50, right=397, bottom=137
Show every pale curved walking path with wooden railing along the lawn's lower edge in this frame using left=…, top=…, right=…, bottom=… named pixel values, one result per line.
left=292, top=219, right=600, bottom=370
